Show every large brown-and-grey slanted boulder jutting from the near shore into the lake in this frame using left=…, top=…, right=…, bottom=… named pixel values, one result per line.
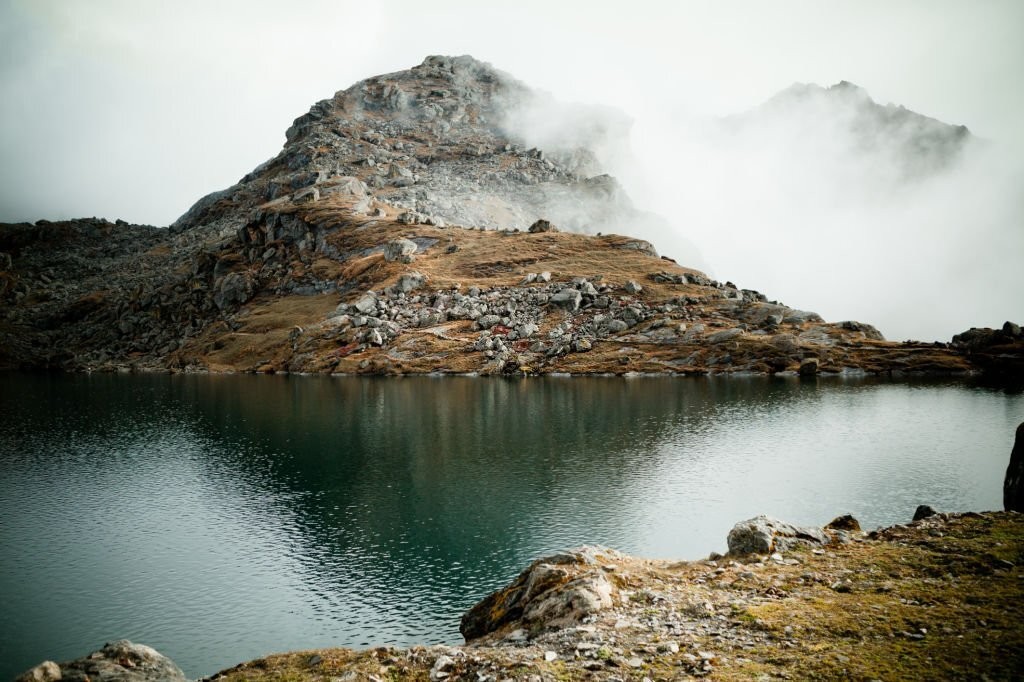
left=459, top=547, right=623, bottom=641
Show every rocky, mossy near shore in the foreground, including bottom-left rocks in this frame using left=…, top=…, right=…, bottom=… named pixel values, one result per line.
left=18, top=507, right=1024, bottom=682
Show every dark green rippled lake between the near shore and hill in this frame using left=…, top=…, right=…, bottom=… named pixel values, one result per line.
left=0, top=374, right=1024, bottom=680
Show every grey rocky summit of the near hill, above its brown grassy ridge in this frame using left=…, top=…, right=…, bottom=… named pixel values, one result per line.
left=171, top=56, right=658, bottom=241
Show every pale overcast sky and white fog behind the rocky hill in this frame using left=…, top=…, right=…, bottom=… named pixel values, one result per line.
left=0, top=0, right=1024, bottom=340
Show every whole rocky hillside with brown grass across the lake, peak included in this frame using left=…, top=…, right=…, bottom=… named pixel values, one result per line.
left=0, top=57, right=1015, bottom=374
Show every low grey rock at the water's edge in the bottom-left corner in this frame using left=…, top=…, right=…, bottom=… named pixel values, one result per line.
left=15, top=639, right=185, bottom=682
